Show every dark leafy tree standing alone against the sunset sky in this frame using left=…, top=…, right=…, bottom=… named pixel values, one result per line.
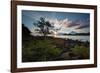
left=33, top=17, right=53, bottom=37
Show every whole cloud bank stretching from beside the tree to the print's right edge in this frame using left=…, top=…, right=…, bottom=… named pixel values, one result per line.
left=46, top=18, right=89, bottom=30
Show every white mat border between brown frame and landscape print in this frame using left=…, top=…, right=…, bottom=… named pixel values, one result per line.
left=17, top=5, right=94, bottom=68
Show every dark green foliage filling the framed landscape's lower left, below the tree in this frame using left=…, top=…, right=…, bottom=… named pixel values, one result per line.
left=23, top=40, right=61, bottom=61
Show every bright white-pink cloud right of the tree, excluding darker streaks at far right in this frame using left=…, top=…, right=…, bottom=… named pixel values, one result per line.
left=46, top=18, right=80, bottom=29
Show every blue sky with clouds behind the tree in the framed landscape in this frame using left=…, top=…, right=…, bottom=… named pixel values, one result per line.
left=22, top=10, right=90, bottom=33
